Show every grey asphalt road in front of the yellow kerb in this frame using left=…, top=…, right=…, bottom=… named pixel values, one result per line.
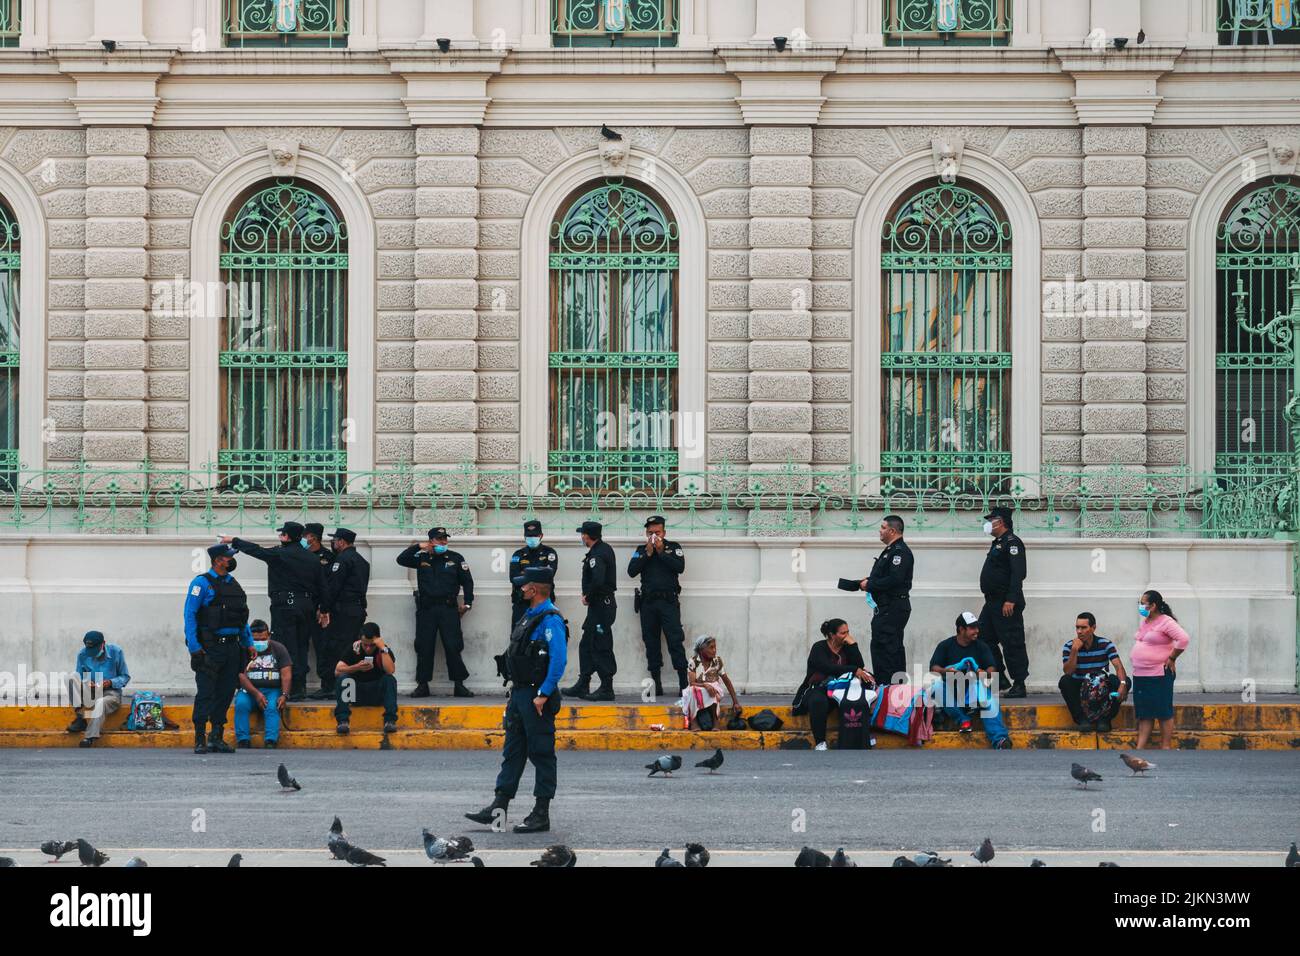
left=0, top=749, right=1300, bottom=866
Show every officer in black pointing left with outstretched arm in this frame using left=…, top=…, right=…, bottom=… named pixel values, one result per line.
left=221, top=522, right=320, bottom=701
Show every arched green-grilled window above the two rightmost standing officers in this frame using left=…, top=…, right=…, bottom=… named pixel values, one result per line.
left=880, top=183, right=1011, bottom=492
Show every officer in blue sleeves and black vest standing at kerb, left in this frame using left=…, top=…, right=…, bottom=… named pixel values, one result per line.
left=185, top=544, right=255, bottom=753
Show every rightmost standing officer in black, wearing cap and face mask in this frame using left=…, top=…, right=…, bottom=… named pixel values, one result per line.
left=979, top=507, right=1030, bottom=697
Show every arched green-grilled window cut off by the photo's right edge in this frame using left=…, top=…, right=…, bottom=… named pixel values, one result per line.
left=1214, top=179, right=1300, bottom=476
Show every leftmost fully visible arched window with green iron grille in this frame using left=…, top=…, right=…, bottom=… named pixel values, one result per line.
left=217, top=179, right=347, bottom=489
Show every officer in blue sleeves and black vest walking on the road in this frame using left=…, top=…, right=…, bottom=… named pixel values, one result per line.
left=465, top=566, right=568, bottom=834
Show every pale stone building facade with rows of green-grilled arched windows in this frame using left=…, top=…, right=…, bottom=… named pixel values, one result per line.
left=0, top=0, right=1300, bottom=687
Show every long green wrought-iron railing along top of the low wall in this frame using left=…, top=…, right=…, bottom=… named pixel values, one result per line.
left=0, top=462, right=1300, bottom=538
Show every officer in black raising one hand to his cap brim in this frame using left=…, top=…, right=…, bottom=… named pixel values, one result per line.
left=398, top=528, right=475, bottom=697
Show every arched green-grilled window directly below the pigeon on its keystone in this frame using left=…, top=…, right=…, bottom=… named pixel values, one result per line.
left=547, top=182, right=677, bottom=489
